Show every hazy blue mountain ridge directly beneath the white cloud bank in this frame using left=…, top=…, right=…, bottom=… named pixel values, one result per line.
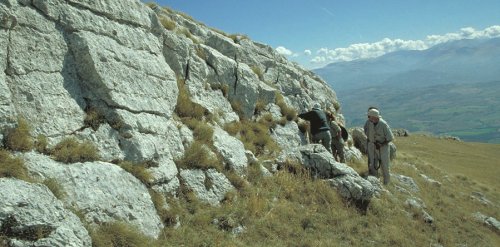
left=314, top=38, right=500, bottom=91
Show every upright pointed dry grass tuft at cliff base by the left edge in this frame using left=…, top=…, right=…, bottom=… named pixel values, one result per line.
left=5, top=117, right=34, bottom=152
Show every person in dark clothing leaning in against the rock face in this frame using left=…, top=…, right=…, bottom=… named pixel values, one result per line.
left=299, top=103, right=332, bottom=153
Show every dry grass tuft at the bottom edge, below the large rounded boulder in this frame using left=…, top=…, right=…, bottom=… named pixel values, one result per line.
left=91, top=221, right=154, bottom=247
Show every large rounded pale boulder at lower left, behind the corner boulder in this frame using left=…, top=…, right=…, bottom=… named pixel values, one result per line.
left=23, top=153, right=163, bottom=237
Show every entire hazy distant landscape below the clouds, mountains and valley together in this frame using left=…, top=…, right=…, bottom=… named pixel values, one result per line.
left=314, top=38, right=500, bottom=143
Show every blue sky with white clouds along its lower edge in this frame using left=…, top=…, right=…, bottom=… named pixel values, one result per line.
left=144, top=0, right=500, bottom=69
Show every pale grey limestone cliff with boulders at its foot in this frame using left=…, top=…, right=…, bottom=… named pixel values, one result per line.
left=0, top=0, right=366, bottom=245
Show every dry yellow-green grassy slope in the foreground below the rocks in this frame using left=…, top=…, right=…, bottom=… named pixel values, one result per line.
left=89, top=135, right=500, bottom=246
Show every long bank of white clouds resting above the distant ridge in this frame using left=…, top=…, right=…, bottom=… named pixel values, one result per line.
left=310, top=26, right=500, bottom=65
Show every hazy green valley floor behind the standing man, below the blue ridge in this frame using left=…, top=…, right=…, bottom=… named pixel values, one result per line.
left=339, top=81, right=500, bottom=143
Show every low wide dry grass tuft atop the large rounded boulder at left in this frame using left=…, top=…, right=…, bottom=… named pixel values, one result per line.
left=51, top=137, right=99, bottom=163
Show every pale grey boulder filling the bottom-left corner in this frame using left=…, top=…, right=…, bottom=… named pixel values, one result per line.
left=0, top=178, right=92, bottom=247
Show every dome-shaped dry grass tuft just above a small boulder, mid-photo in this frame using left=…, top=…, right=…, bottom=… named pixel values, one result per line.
left=175, top=141, right=222, bottom=171
